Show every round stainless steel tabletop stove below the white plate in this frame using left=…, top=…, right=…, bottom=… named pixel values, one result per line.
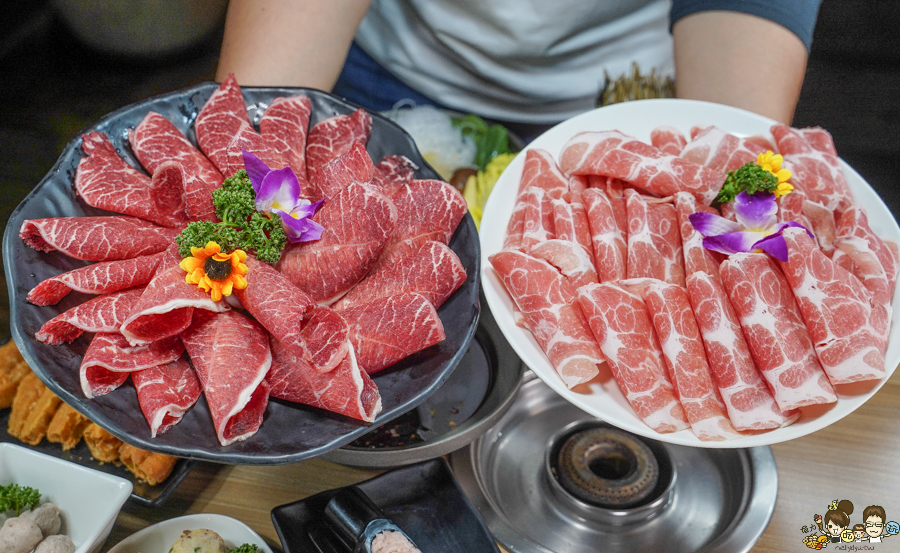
left=450, top=372, right=778, bottom=553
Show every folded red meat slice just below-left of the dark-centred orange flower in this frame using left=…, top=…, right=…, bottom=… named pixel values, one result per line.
left=118, top=265, right=229, bottom=346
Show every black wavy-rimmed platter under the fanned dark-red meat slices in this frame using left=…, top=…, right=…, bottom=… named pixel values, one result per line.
left=3, top=83, right=481, bottom=464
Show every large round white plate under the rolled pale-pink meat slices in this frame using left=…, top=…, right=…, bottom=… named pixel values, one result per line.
left=479, top=99, right=900, bottom=447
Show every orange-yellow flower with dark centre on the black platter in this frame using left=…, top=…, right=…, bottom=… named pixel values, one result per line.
left=180, top=241, right=247, bottom=301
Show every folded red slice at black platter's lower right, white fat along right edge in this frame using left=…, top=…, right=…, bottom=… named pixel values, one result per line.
left=266, top=337, right=381, bottom=422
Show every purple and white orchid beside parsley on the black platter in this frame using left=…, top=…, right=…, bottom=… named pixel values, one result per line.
left=241, top=150, right=325, bottom=243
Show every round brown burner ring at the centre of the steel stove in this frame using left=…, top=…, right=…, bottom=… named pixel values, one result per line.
left=557, top=427, right=659, bottom=508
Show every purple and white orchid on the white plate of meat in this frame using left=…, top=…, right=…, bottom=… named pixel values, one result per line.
left=688, top=192, right=813, bottom=261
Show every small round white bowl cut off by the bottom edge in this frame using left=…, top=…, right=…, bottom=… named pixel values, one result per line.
left=108, top=513, right=272, bottom=553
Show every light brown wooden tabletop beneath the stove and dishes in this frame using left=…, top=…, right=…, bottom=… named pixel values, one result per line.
left=102, top=364, right=900, bottom=553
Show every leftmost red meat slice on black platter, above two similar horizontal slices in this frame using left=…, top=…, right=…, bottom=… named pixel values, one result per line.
left=19, top=216, right=180, bottom=261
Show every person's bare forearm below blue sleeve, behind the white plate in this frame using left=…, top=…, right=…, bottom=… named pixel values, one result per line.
left=672, top=11, right=807, bottom=124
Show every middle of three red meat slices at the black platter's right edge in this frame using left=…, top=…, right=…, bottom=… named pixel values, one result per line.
left=332, top=240, right=466, bottom=310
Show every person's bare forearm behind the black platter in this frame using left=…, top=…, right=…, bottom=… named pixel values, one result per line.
left=216, top=0, right=369, bottom=90
